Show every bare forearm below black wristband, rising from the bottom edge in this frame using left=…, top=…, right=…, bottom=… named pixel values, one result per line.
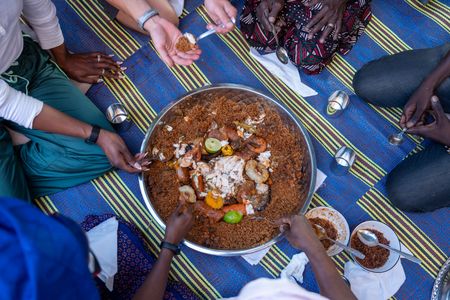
left=133, top=249, right=173, bottom=300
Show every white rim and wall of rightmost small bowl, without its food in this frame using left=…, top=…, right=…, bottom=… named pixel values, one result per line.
left=350, top=221, right=400, bottom=273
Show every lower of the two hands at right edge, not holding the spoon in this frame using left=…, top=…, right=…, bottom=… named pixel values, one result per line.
left=406, top=96, right=450, bottom=146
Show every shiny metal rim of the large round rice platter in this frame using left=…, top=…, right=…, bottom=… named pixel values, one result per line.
left=139, top=84, right=316, bottom=256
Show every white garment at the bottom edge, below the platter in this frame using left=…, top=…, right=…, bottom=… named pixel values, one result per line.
left=227, top=278, right=327, bottom=300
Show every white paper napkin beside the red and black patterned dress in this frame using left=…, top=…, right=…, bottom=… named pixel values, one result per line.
left=250, top=48, right=317, bottom=97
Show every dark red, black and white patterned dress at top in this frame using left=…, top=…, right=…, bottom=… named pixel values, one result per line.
left=240, top=0, right=372, bottom=74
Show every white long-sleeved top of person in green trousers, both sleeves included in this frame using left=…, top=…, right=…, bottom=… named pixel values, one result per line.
left=0, top=0, right=64, bottom=128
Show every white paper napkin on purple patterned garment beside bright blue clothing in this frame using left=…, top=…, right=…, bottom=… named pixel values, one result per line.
left=86, top=217, right=119, bottom=291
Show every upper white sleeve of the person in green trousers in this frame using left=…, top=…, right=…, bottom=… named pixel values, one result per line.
left=22, top=0, right=64, bottom=50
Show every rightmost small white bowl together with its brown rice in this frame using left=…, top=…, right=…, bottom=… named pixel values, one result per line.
left=350, top=221, right=400, bottom=273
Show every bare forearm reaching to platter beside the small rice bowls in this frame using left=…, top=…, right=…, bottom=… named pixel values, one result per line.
left=305, top=245, right=356, bottom=300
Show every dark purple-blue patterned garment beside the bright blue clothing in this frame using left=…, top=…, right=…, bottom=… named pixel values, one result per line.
left=81, top=214, right=197, bottom=300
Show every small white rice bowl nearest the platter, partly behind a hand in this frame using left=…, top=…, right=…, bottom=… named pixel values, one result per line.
left=305, top=206, right=350, bottom=256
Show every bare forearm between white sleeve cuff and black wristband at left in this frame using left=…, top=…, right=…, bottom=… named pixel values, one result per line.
left=33, top=104, right=92, bottom=139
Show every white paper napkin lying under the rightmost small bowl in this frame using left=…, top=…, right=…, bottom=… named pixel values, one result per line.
left=344, top=244, right=411, bottom=300
